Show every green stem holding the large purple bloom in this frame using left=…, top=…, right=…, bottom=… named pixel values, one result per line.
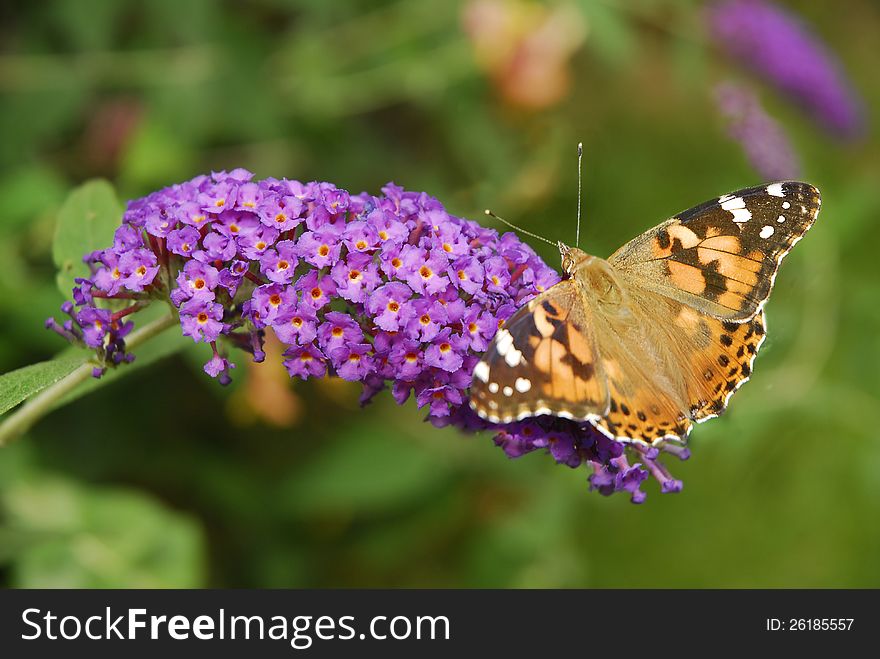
left=0, top=313, right=177, bottom=446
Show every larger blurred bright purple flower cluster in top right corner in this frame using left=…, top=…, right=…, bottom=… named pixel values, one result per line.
left=707, top=0, right=864, bottom=138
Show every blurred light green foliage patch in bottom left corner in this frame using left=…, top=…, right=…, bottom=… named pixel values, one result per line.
left=0, top=475, right=204, bottom=588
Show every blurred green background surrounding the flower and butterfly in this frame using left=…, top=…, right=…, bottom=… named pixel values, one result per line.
left=0, top=0, right=880, bottom=587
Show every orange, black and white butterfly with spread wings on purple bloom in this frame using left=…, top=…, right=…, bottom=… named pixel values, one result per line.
left=470, top=181, right=821, bottom=446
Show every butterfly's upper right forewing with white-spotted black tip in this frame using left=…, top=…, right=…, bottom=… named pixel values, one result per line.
left=608, top=181, right=821, bottom=322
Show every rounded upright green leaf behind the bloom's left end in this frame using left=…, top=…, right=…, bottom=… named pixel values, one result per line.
left=52, top=179, right=122, bottom=298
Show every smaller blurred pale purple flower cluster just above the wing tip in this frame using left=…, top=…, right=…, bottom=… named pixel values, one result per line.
left=715, top=83, right=800, bottom=181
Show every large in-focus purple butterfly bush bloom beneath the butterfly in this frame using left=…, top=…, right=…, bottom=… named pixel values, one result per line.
left=47, top=169, right=687, bottom=502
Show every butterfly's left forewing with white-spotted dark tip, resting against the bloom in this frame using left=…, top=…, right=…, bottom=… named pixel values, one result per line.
left=470, top=280, right=608, bottom=423
